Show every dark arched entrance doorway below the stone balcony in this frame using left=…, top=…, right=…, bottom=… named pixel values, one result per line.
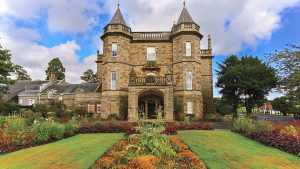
left=138, top=90, right=164, bottom=119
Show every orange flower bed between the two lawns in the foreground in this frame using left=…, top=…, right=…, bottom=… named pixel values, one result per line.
left=93, top=136, right=206, bottom=169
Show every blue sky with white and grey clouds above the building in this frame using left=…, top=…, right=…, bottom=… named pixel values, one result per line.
left=0, top=0, right=300, bottom=98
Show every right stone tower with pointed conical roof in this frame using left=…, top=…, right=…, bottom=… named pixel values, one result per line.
left=172, top=3, right=203, bottom=119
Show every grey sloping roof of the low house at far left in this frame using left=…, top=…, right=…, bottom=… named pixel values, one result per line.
left=3, top=80, right=49, bottom=101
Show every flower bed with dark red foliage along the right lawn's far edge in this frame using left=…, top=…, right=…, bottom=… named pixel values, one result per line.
left=233, top=119, right=300, bottom=156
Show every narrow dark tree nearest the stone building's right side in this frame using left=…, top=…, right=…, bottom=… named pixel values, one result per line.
left=216, top=55, right=241, bottom=117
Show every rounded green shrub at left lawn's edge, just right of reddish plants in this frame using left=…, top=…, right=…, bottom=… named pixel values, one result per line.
left=33, top=122, right=50, bottom=143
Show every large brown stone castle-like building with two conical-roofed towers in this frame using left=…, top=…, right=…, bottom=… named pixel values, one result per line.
left=96, top=5, right=213, bottom=121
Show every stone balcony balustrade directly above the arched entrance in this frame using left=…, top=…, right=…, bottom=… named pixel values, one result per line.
left=129, top=76, right=167, bottom=86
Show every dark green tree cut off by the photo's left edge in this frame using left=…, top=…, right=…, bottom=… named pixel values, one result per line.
left=0, top=45, right=14, bottom=97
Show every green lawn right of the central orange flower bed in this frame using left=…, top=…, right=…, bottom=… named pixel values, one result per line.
left=178, top=130, right=300, bottom=169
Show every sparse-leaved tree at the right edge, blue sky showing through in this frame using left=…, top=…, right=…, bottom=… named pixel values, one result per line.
left=267, top=44, right=300, bottom=99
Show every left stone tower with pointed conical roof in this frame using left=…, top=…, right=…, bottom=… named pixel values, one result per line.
left=97, top=4, right=131, bottom=118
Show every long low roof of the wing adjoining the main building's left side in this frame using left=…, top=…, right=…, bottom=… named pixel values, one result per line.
left=48, top=83, right=100, bottom=94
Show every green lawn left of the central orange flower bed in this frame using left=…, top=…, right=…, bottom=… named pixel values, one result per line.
left=0, top=134, right=124, bottom=169
